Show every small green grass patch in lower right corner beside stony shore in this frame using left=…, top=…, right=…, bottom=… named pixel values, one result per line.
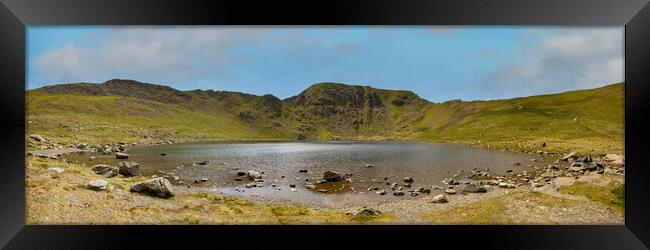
left=560, top=181, right=625, bottom=212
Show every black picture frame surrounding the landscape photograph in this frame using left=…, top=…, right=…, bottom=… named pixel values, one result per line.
left=0, top=0, right=650, bottom=249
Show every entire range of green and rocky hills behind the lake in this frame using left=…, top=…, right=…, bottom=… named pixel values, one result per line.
left=27, top=79, right=624, bottom=153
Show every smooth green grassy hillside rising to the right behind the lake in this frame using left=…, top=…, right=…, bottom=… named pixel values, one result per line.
left=417, top=83, right=625, bottom=153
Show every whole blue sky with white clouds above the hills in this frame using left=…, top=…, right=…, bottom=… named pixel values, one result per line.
left=26, top=26, right=624, bottom=102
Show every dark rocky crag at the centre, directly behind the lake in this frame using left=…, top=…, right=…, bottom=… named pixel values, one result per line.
left=284, top=83, right=429, bottom=139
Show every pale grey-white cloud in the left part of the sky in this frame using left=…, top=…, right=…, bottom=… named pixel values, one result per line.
left=34, top=28, right=264, bottom=86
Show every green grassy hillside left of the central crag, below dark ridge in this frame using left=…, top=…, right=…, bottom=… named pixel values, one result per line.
left=26, top=79, right=290, bottom=143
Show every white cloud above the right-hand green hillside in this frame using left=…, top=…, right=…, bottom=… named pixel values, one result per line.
left=477, top=28, right=624, bottom=99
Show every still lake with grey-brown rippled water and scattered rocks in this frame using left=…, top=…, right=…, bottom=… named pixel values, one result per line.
left=67, top=141, right=550, bottom=205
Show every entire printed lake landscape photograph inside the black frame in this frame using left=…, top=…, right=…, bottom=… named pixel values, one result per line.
left=25, top=26, right=625, bottom=225
